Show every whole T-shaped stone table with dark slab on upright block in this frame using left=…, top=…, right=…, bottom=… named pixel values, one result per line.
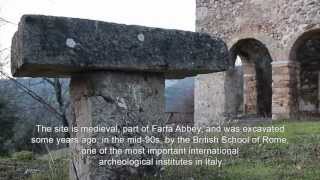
left=11, top=15, right=229, bottom=180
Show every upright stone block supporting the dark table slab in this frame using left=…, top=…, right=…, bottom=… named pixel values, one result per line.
left=70, top=72, right=164, bottom=180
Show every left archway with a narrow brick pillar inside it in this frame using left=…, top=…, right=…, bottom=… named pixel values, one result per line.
left=226, top=38, right=272, bottom=117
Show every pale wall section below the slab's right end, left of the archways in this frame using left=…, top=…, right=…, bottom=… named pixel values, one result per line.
left=194, top=67, right=243, bottom=126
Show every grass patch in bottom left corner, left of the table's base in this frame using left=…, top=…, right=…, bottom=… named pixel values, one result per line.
left=0, top=150, right=69, bottom=180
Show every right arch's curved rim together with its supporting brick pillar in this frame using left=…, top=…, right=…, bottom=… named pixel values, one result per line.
left=272, top=27, right=320, bottom=119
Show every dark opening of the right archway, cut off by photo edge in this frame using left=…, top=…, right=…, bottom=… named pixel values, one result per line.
left=289, top=28, right=320, bottom=116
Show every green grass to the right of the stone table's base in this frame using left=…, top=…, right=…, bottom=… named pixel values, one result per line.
left=165, top=121, right=320, bottom=180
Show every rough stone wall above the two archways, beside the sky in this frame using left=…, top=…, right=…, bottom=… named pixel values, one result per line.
left=196, top=0, right=320, bottom=56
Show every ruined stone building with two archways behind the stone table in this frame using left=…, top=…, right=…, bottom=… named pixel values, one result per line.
left=194, top=0, right=320, bottom=125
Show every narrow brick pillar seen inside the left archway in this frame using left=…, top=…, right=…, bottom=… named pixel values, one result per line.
left=243, top=63, right=258, bottom=115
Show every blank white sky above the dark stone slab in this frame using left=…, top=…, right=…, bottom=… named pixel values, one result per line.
left=0, top=0, right=196, bottom=75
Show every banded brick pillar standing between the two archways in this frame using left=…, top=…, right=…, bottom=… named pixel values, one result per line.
left=272, top=61, right=299, bottom=119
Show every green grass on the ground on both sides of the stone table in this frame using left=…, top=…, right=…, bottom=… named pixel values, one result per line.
left=0, top=121, right=320, bottom=180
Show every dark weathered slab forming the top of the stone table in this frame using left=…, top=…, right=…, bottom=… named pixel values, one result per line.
left=11, top=15, right=228, bottom=78
